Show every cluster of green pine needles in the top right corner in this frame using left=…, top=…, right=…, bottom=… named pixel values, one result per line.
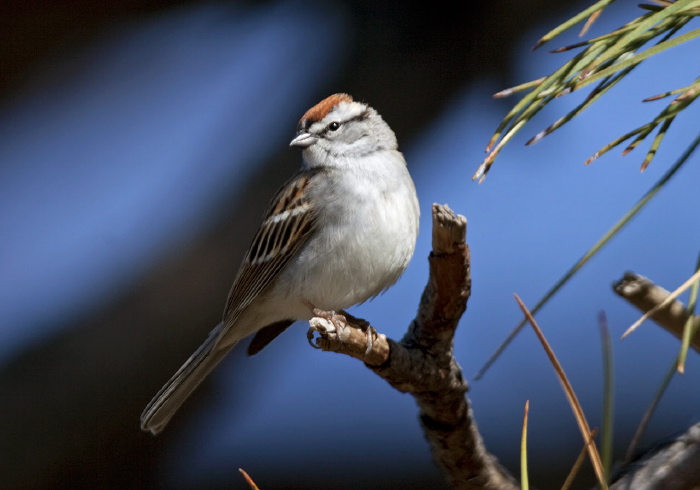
left=472, top=0, right=700, bottom=182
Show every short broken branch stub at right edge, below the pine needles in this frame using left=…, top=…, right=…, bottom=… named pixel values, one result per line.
left=613, top=272, right=700, bottom=352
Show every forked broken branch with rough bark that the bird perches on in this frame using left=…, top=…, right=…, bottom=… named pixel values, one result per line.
left=309, top=204, right=519, bottom=490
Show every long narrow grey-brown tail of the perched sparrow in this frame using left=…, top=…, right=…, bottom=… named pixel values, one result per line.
left=141, top=324, right=236, bottom=434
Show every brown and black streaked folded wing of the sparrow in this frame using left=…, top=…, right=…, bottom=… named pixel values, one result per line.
left=219, top=168, right=321, bottom=338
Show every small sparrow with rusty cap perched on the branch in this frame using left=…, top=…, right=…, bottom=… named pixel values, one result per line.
left=141, top=93, right=420, bottom=434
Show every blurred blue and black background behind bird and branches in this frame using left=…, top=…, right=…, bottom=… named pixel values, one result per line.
left=0, top=0, right=700, bottom=488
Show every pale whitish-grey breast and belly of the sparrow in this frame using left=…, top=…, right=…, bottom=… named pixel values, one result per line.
left=273, top=151, right=419, bottom=310
